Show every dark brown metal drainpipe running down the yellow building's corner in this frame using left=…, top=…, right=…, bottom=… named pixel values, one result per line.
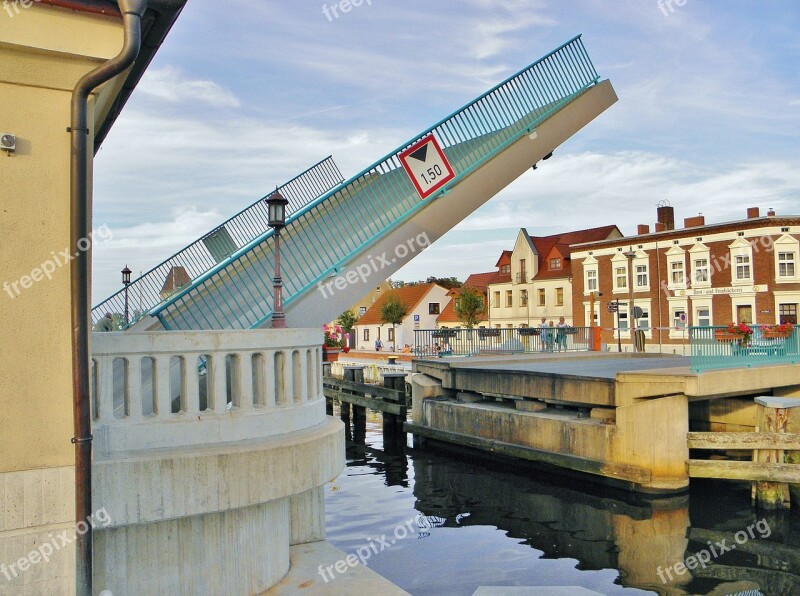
left=67, top=0, right=147, bottom=596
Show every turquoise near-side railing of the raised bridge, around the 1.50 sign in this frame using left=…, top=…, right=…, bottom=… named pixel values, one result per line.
left=151, top=36, right=600, bottom=329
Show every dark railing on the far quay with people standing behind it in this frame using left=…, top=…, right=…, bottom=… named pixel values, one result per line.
left=413, top=326, right=592, bottom=358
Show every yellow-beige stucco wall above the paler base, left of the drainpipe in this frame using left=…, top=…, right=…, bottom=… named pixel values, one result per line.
left=0, top=4, right=122, bottom=473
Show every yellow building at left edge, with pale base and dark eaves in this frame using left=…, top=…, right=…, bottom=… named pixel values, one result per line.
left=0, top=0, right=183, bottom=594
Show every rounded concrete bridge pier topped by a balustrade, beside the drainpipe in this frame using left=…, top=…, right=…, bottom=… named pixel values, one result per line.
left=87, top=329, right=345, bottom=596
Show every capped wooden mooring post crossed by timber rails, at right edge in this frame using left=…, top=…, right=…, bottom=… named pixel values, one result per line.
left=755, top=396, right=800, bottom=509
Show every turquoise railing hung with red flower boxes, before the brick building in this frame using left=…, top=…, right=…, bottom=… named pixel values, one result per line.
left=689, top=324, right=800, bottom=372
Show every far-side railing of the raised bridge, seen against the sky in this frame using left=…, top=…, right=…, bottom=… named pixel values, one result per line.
left=92, top=156, right=344, bottom=328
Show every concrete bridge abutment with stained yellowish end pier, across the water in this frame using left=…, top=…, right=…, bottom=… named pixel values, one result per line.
left=405, top=353, right=800, bottom=495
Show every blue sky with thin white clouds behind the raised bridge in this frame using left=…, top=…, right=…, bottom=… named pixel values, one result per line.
left=93, top=0, right=800, bottom=304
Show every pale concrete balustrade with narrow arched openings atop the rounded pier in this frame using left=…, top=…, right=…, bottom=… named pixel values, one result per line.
left=92, top=329, right=325, bottom=456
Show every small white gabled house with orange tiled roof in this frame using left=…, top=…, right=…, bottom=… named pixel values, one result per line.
left=355, top=283, right=451, bottom=351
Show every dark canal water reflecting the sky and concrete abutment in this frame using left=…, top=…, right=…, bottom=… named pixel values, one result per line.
left=326, top=411, right=800, bottom=596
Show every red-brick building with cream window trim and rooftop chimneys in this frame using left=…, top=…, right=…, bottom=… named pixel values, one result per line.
left=571, top=206, right=800, bottom=353
